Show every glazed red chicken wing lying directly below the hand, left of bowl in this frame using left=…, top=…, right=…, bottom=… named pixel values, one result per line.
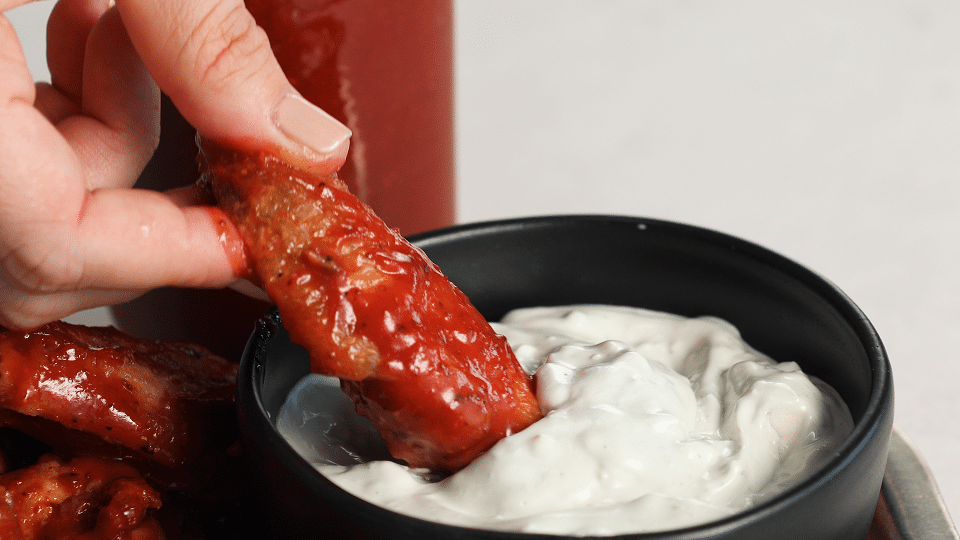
left=0, top=321, right=236, bottom=468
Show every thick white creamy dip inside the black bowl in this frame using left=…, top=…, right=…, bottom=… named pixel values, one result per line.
left=278, top=306, right=853, bottom=535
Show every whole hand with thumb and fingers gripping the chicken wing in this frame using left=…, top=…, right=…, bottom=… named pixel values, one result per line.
left=0, top=0, right=350, bottom=328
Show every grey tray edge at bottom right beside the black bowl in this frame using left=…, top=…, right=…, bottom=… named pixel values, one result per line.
left=878, top=428, right=960, bottom=540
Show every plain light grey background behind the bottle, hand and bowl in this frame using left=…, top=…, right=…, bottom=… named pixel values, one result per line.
left=10, top=0, right=960, bottom=518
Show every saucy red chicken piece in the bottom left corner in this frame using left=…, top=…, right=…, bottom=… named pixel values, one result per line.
left=0, top=455, right=164, bottom=540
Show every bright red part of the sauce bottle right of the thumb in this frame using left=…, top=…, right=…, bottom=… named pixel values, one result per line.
left=246, top=0, right=454, bottom=234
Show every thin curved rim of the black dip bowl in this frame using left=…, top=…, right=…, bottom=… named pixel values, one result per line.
left=237, top=214, right=893, bottom=540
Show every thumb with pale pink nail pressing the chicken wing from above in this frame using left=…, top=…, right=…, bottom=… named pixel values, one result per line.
left=117, top=0, right=350, bottom=174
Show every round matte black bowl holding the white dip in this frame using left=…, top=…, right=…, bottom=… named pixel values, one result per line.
left=238, top=216, right=893, bottom=540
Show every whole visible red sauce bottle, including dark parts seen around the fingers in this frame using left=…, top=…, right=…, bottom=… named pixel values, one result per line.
left=113, top=0, right=455, bottom=360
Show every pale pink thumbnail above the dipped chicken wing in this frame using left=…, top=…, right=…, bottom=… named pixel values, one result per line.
left=273, top=92, right=352, bottom=155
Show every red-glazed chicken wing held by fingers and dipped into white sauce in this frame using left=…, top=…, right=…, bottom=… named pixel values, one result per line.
left=203, top=143, right=540, bottom=471
